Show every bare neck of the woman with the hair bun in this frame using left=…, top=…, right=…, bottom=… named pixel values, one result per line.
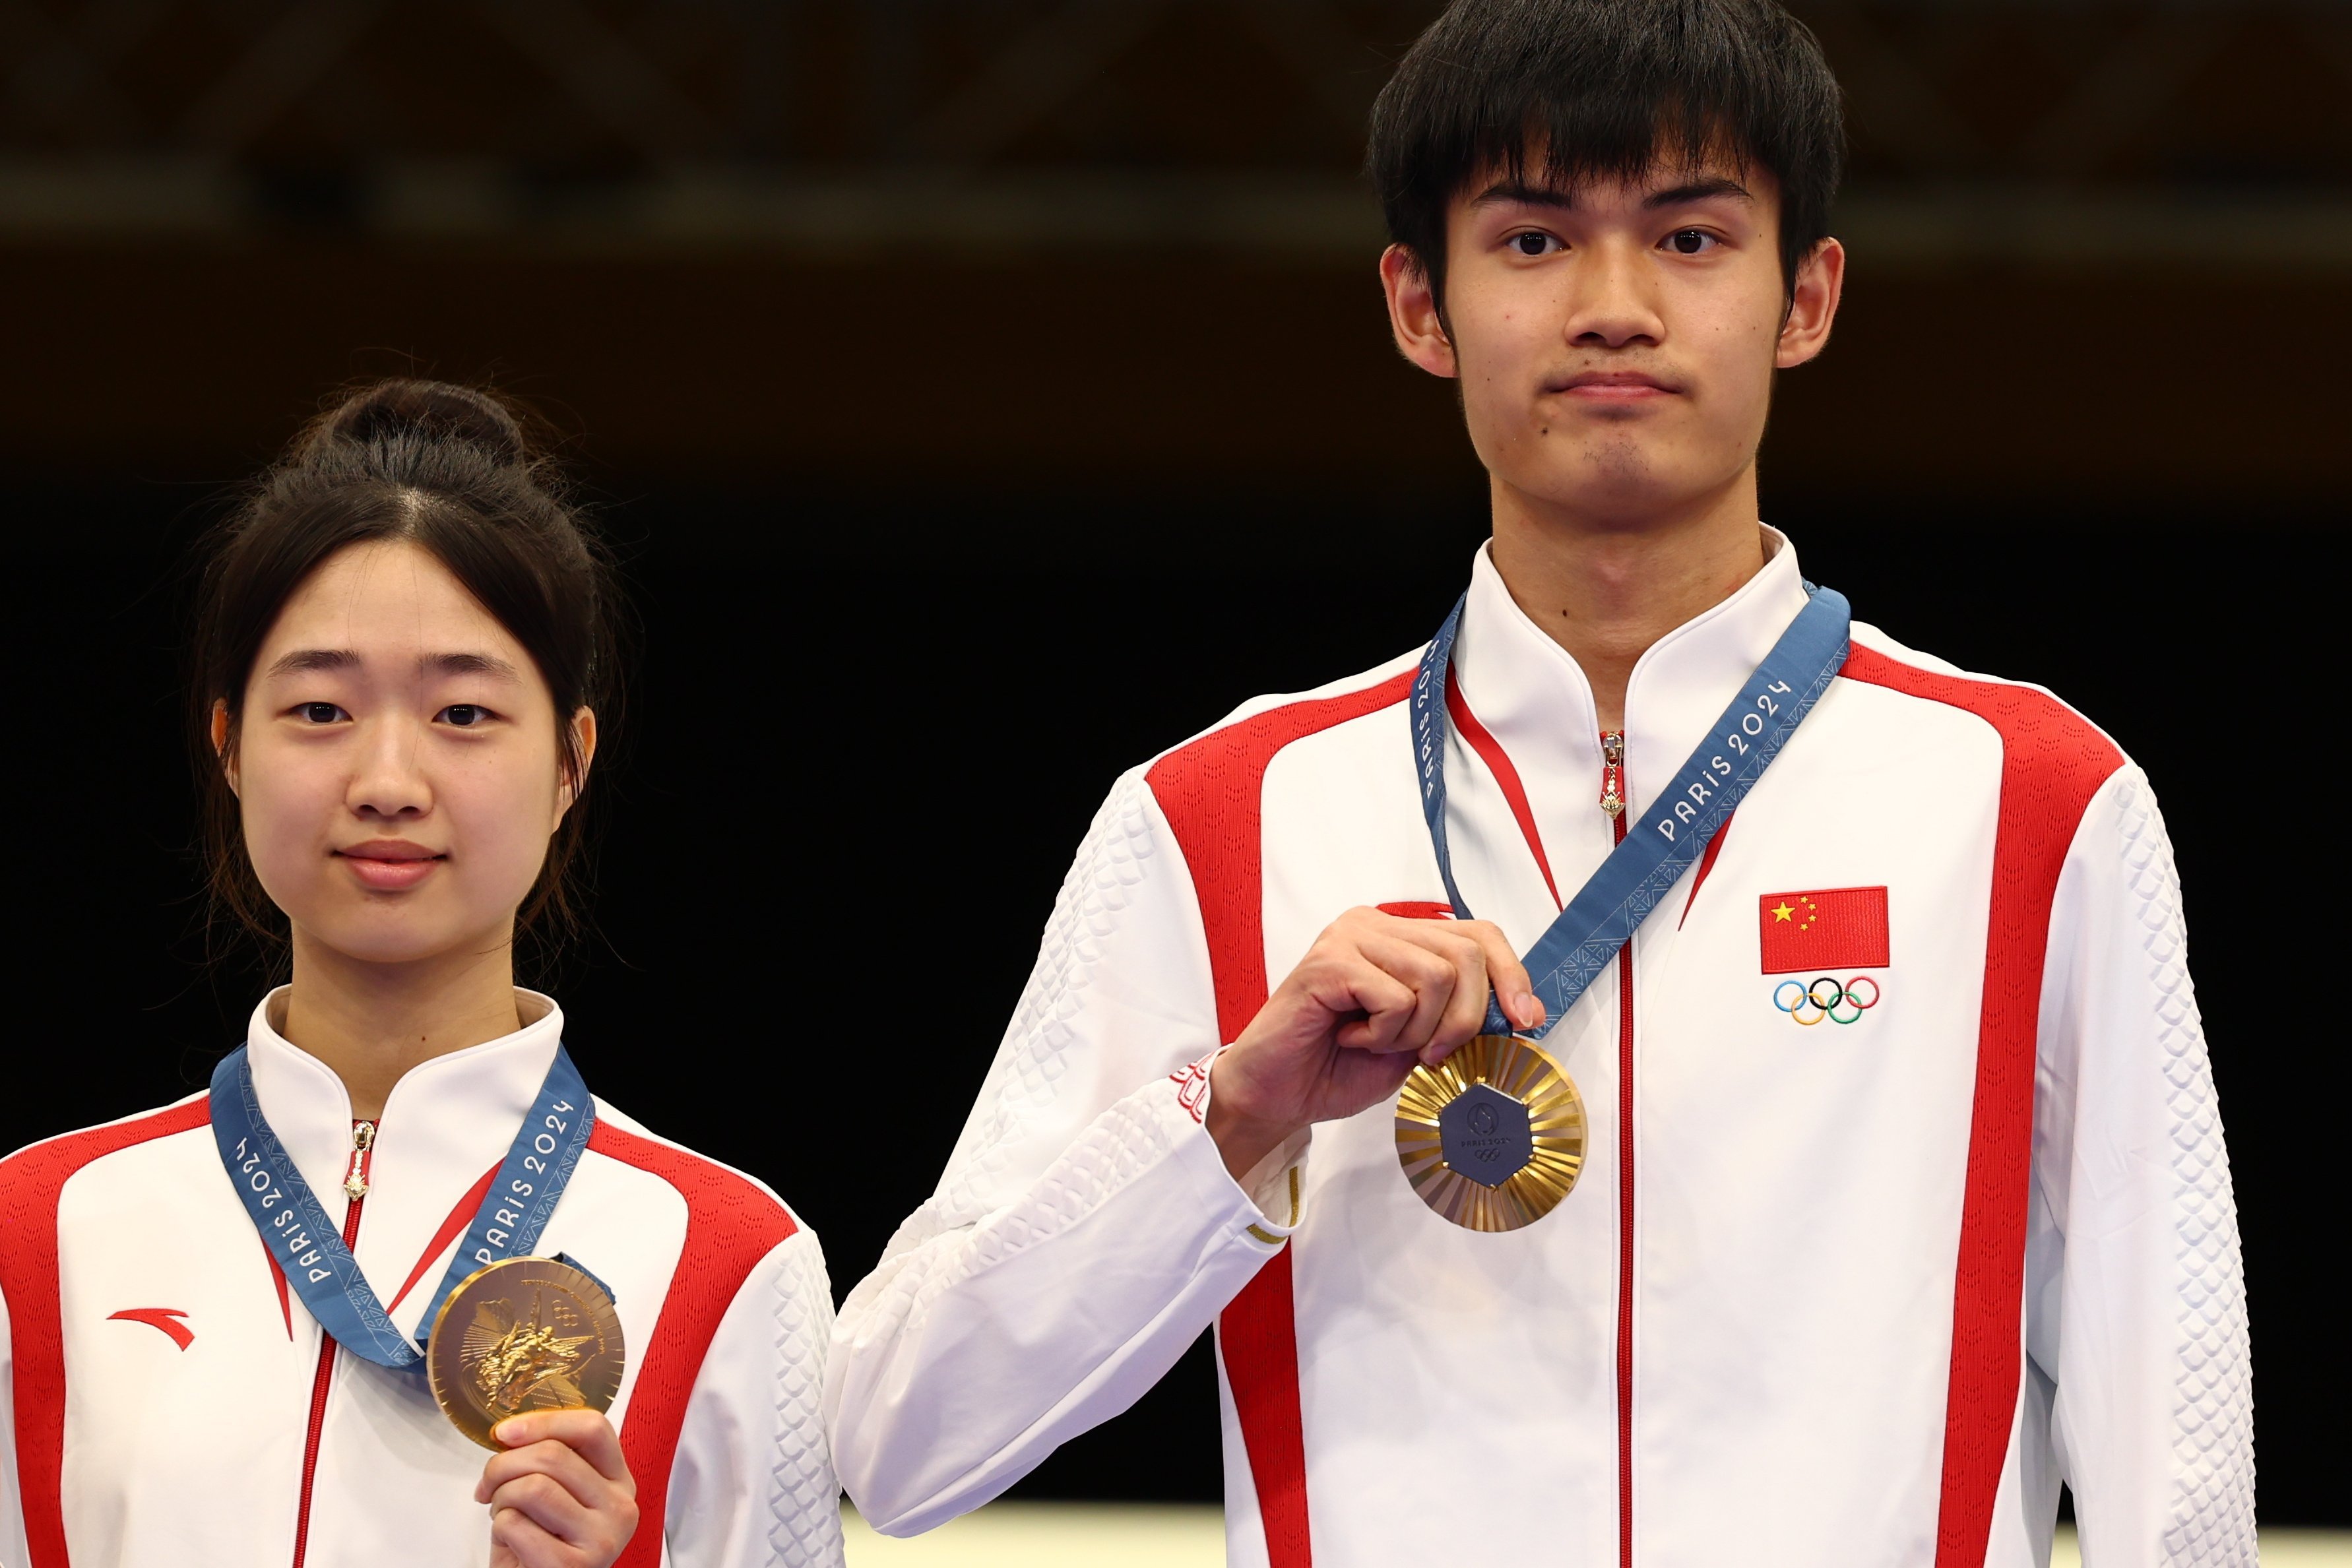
left=270, top=929, right=522, bottom=1121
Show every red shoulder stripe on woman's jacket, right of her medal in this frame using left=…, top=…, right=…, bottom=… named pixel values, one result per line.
left=588, top=1119, right=798, bottom=1568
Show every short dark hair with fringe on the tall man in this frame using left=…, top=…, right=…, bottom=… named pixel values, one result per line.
left=1364, top=0, right=1847, bottom=303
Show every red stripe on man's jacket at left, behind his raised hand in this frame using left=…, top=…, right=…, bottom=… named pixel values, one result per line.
left=1145, top=670, right=1414, bottom=1568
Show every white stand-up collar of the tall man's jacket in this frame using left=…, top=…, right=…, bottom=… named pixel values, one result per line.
left=1453, top=524, right=1806, bottom=841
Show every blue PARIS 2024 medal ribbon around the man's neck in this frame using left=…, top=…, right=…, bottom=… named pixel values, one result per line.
left=1414, top=583, right=1853, bottom=1039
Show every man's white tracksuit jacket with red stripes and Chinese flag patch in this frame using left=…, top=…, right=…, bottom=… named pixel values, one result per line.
left=825, top=534, right=2253, bottom=1568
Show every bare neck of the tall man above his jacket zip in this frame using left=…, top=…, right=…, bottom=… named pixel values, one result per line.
left=1494, top=468, right=1764, bottom=731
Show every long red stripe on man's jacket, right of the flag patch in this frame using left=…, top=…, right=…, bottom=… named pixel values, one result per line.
left=1839, top=646, right=2124, bottom=1568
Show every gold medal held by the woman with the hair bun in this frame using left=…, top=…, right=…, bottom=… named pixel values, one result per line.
left=426, top=1258, right=628, bottom=1451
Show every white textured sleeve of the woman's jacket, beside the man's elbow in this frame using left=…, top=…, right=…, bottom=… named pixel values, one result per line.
left=663, top=1230, right=842, bottom=1568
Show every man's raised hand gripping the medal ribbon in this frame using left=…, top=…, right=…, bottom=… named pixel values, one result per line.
left=1209, top=910, right=1543, bottom=1180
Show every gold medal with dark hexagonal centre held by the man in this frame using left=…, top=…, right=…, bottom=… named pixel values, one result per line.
left=1397, top=1034, right=1585, bottom=1230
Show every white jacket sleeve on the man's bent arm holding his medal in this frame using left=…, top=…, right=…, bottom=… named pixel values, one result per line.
left=825, top=773, right=1306, bottom=1535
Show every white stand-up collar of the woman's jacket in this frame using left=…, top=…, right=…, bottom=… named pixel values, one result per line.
left=245, top=988, right=565, bottom=1215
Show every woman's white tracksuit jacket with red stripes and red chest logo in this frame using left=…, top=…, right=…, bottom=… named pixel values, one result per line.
left=0, top=992, right=842, bottom=1568
